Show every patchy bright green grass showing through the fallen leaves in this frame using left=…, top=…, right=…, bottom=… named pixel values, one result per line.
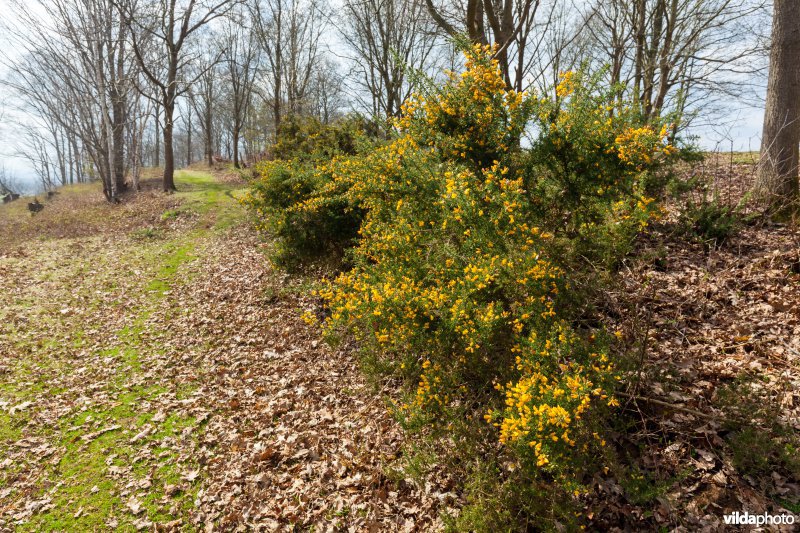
left=0, top=167, right=238, bottom=531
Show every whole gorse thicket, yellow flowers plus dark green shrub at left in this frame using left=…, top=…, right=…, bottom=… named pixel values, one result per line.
left=244, top=42, right=677, bottom=531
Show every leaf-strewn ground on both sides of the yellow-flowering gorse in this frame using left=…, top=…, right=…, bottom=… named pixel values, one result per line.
left=0, top=163, right=800, bottom=531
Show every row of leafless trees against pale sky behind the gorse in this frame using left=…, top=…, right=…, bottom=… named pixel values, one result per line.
left=3, top=0, right=769, bottom=201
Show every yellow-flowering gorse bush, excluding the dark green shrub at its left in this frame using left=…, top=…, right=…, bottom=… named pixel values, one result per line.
left=247, top=42, right=673, bottom=524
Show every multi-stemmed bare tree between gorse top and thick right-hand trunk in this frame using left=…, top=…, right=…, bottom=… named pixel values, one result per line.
left=581, top=0, right=765, bottom=127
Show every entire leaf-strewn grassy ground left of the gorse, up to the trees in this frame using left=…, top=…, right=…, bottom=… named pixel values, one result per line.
left=0, top=171, right=440, bottom=531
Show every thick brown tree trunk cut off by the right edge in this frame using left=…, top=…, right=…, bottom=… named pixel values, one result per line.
left=755, top=0, right=800, bottom=210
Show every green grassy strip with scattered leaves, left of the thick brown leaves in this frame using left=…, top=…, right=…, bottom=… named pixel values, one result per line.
left=0, top=171, right=247, bottom=531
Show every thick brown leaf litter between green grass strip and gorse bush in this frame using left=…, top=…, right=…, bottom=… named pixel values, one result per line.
left=173, top=231, right=446, bottom=531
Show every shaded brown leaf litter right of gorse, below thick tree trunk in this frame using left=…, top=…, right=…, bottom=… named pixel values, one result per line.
left=589, top=165, right=800, bottom=531
